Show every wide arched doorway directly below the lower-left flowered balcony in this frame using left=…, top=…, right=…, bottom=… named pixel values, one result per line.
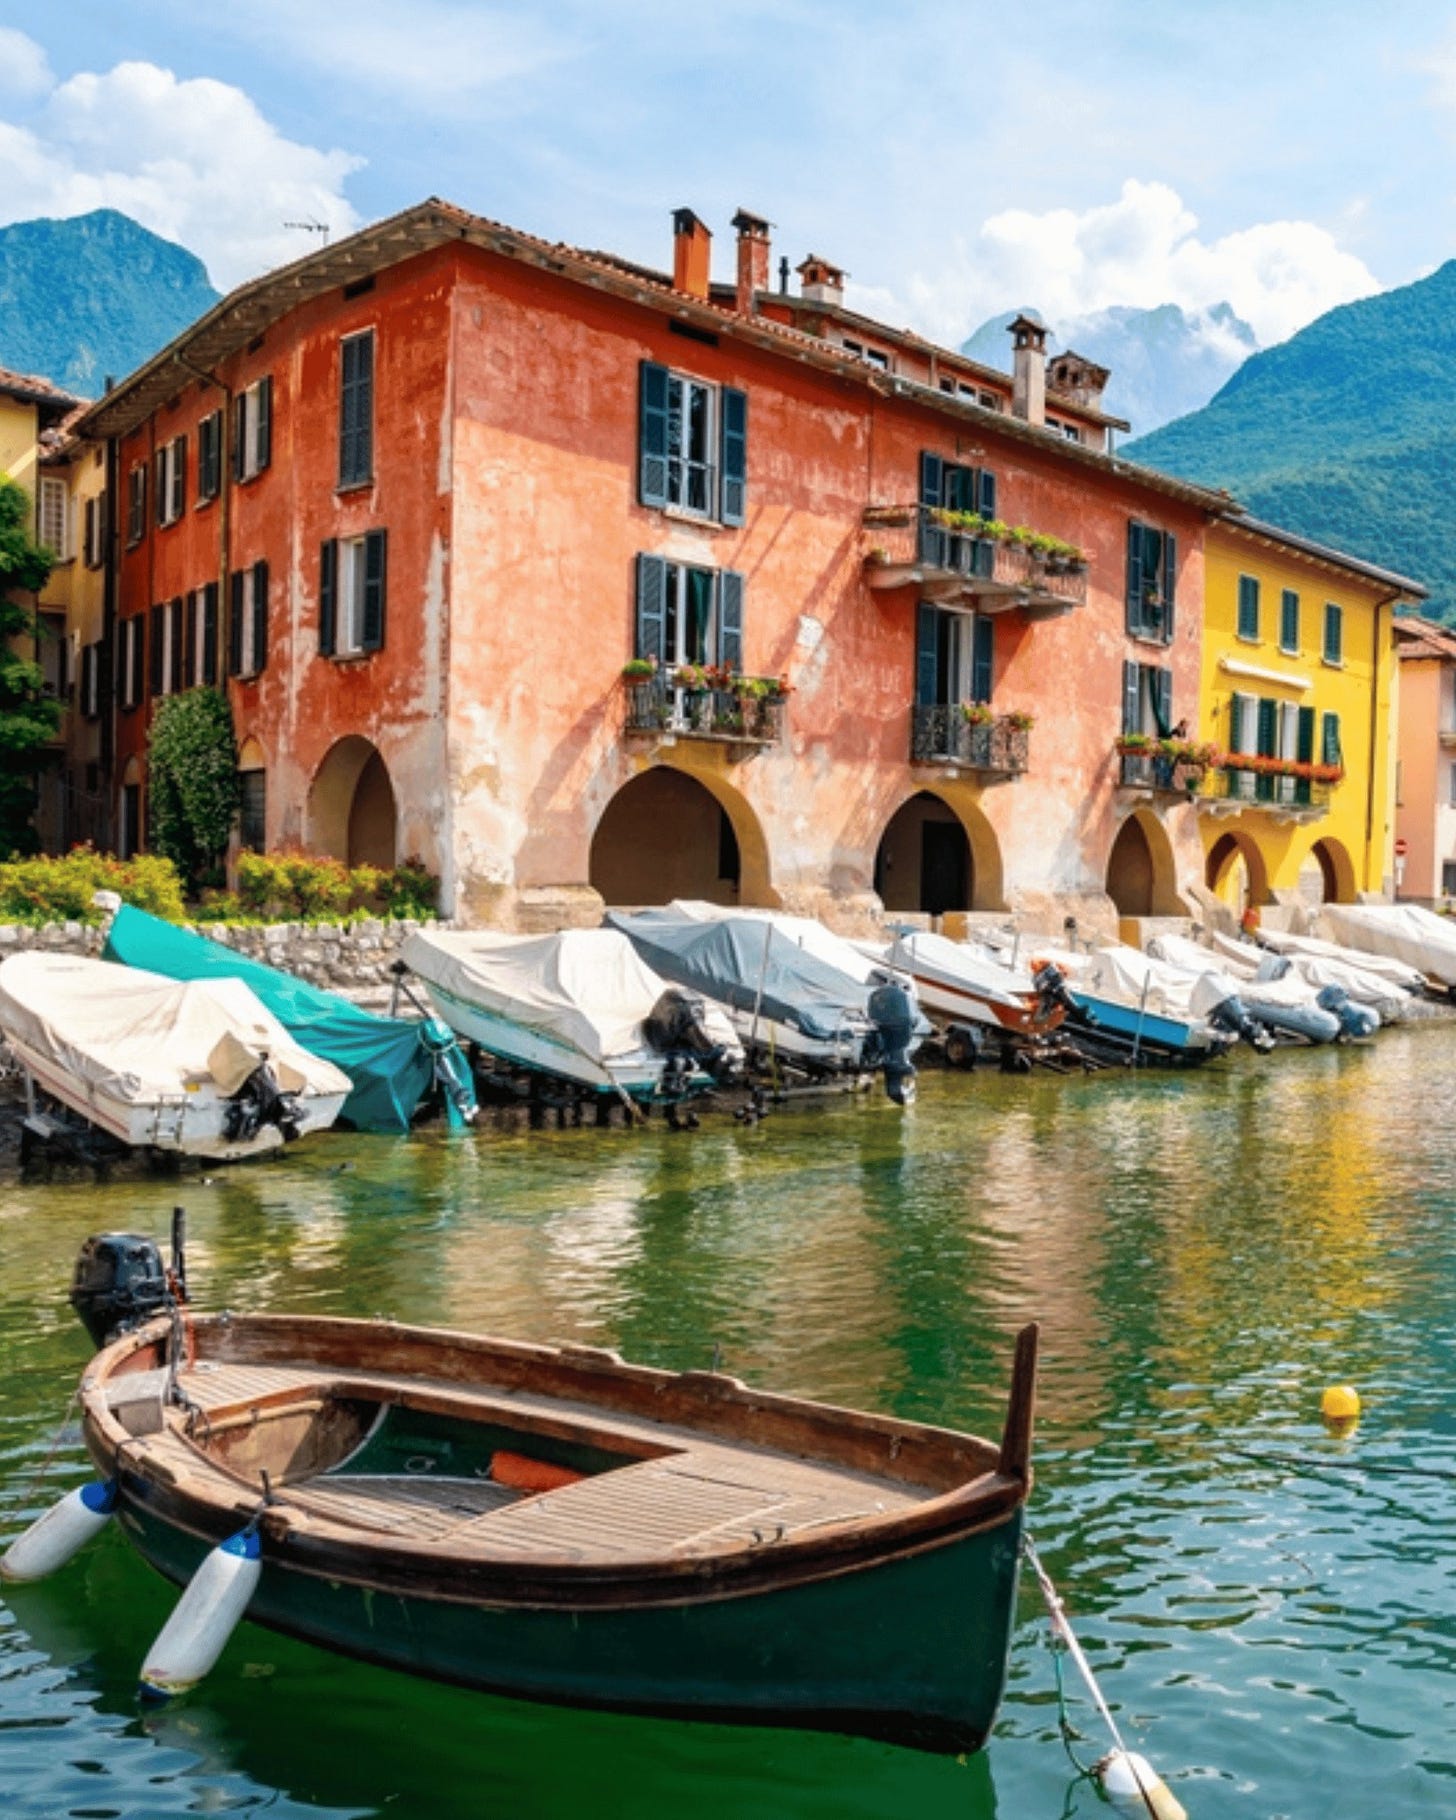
left=590, top=764, right=768, bottom=906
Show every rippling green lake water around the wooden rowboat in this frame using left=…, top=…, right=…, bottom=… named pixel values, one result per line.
left=0, top=1028, right=1456, bottom=1820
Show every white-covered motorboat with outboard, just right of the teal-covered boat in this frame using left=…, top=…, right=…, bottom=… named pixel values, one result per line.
left=400, top=928, right=743, bottom=1099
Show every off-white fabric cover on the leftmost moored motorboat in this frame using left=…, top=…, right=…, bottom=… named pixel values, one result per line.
left=0, top=954, right=349, bottom=1105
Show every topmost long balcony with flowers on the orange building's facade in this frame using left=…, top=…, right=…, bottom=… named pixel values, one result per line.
left=865, top=506, right=1087, bottom=619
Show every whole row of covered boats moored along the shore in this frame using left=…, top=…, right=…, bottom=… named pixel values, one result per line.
left=0, top=901, right=1456, bottom=1159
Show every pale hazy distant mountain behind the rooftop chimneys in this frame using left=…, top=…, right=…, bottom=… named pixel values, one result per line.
left=961, top=304, right=1258, bottom=435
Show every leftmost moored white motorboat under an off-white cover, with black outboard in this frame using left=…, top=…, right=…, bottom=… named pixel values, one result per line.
left=0, top=952, right=351, bottom=1161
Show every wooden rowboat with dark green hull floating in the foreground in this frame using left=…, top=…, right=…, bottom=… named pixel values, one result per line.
left=82, top=1310, right=1036, bottom=1751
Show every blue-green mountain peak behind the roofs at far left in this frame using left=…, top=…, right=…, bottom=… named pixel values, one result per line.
left=0, top=209, right=218, bottom=399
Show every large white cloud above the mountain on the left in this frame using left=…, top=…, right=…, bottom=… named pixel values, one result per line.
left=0, top=64, right=364, bottom=289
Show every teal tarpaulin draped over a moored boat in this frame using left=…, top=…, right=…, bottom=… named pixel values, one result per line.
left=104, top=905, right=435, bottom=1132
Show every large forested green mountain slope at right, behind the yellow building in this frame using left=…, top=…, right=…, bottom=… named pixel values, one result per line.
left=1123, top=260, right=1456, bottom=619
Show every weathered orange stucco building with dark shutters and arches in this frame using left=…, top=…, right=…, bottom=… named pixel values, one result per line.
left=82, top=202, right=1230, bottom=928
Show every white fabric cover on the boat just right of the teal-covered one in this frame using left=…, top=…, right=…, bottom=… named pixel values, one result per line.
left=400, top=928, right=739, bottom=1065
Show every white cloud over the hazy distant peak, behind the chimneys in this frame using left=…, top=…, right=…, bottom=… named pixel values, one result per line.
left=859, top=178, right=1380, bottom=348
